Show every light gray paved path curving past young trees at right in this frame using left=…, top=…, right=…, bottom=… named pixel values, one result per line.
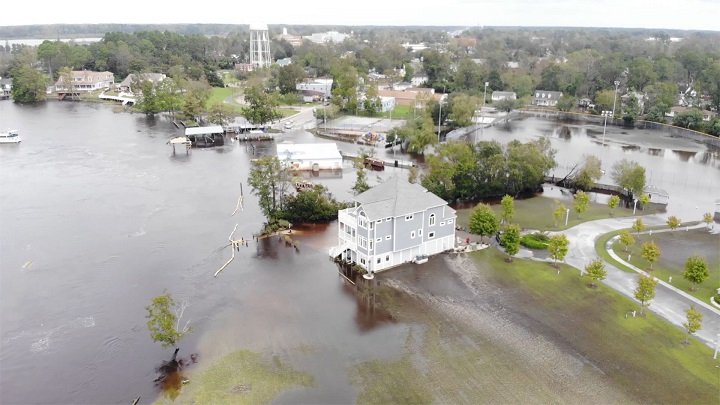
left=562, top=215, right=720, bottom=349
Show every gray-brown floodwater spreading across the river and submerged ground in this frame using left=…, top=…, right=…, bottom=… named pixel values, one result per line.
left=0, top=101, right=718, bottom=404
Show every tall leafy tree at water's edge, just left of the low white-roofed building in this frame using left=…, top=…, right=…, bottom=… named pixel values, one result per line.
left=248, top=156, right=290, bottom=220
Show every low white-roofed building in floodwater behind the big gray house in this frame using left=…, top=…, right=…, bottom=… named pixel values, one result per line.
left=277, top=142, right=342, bottom=172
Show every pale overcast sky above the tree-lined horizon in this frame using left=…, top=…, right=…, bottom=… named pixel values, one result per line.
left=5, top=0, right=720, bottom=31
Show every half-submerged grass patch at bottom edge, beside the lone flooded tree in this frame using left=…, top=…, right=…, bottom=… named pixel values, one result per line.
left=163, top=350, right=314, bottom=405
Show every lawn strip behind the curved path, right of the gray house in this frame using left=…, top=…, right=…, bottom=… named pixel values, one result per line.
left=457, top=196, right=654, bottom=231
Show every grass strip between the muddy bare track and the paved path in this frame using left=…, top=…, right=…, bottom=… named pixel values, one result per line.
left=471, top=249, right=720, bottom=403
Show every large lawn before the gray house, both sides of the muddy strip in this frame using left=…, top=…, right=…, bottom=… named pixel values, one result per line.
left=356, top=248, right=720, bottom=404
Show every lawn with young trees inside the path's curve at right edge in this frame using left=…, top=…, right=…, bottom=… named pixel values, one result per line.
left=603, top=229, right=720, bottom=302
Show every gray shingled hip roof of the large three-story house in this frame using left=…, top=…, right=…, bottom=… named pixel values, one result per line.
left=355, top=176, right=454, bottom=221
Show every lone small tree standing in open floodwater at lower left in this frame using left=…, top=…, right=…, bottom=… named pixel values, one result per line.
left=145, top=290, right=192, bottom=348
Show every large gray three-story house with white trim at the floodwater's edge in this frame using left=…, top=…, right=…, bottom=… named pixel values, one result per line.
left=329, top=176, right=457, bottom=272
